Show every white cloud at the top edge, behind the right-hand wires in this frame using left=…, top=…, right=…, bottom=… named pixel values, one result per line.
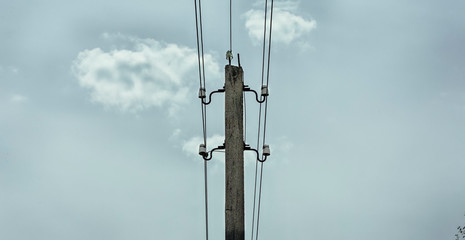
left=243, top=1, right=317, bottom=44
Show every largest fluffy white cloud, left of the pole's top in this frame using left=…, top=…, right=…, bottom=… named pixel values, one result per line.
left=72, top=34, right=220, bottom=113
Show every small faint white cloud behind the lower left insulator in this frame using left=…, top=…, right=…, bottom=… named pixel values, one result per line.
left=182, top=134, right=224, bottom=163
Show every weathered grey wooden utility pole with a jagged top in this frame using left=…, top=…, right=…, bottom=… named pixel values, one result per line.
left=225, top=65, right=245, bottom=240
